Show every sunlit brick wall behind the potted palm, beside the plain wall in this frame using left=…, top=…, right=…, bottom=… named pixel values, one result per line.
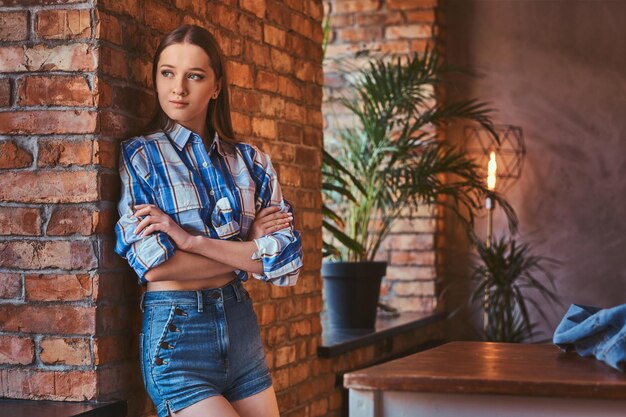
left=322, top=0, right=439, bottom=312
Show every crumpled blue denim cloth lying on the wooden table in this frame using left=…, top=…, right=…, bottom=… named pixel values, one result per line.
left=552, top=304, right=626, bottom=372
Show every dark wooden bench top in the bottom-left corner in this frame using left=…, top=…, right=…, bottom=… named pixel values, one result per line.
left=0, top=399, right=127, bottom=417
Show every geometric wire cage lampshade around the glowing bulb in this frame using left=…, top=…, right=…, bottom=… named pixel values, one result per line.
left=463, top=125, right=526, bottom=194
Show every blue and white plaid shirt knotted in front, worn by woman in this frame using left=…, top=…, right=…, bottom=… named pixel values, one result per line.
left=115, top=124, right=302, bottom=286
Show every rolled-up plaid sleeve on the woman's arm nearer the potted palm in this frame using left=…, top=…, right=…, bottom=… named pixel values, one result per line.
left=246, top=148, right=302, bottom=286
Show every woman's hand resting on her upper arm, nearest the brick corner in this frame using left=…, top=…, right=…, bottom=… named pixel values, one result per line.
left=133, top=204, right=193, bottom=251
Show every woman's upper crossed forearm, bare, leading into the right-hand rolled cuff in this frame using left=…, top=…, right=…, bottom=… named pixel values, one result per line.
left=186, top=236, right=263, bottom=274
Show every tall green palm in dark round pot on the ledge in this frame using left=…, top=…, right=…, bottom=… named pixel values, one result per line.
left=322, top=50, right=516, bottom=328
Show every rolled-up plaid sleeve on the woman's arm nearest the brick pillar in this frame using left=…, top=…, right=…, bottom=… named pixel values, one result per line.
left=115, top=139, right=175, bottom=285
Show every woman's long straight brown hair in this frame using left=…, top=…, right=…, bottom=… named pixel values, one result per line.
left=144, top=25, right=237, bottom=143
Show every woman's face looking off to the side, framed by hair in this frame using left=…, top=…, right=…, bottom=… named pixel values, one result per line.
left=156, top=43, right=220, bottom=134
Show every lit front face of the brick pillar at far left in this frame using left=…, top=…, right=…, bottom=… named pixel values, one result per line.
left=0, top=1, right=108, bottom=400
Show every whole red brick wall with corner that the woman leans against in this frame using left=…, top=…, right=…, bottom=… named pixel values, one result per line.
left=0, top=0, right=328, bottom=416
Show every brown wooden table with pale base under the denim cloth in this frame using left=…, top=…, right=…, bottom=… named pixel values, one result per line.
left=344, top=342, right=626, bottom=417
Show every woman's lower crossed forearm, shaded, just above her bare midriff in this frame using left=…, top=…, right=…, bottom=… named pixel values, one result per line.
left=145, top=249, right=238, bottom=282
